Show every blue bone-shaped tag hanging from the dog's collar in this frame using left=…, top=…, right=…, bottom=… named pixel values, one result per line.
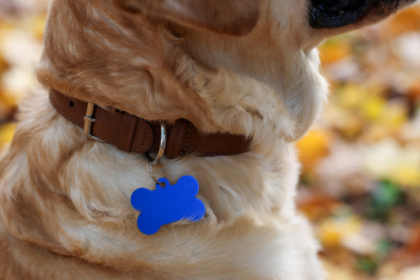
left=131, top=176, right=206, bottom=235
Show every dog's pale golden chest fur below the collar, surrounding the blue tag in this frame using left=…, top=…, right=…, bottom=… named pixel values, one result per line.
left=1, top=83, right=324, bottom=279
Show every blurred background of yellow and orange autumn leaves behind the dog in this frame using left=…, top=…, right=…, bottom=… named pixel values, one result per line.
left=0, top=0, right=420, bottom=280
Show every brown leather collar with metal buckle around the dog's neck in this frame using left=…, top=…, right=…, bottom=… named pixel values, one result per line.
left=50, top=90, right=251, bottom=159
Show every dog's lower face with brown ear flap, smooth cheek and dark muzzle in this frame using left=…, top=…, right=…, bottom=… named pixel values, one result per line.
left=106, top=0, right=414, bottom=136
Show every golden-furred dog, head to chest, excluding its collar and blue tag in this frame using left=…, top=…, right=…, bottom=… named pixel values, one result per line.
left=0, top=0, right=413, bottom=280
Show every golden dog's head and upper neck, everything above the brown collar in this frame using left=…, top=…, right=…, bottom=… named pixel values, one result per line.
left=38, top=0, right=414, bottom=148
